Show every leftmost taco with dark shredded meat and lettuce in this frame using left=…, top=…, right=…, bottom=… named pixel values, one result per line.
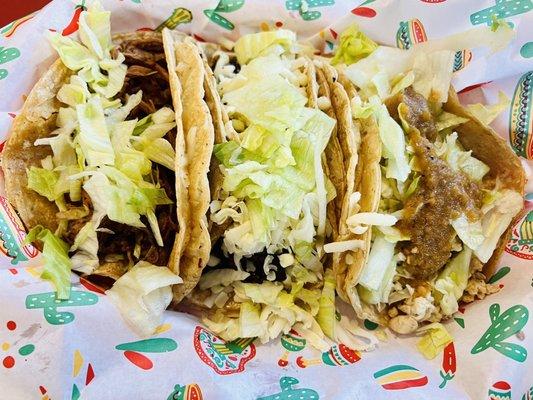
left=2, top=2, right=190, bottom=335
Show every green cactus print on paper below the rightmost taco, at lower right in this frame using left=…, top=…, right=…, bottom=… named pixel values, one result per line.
left=471, top=304, right=529, bottom=362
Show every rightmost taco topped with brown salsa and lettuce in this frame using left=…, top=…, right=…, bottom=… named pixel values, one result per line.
left=334, top=32, right=525, bottom=333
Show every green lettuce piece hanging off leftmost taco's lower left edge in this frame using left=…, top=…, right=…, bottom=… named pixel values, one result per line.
left=26, top=225, right=72, bottom=300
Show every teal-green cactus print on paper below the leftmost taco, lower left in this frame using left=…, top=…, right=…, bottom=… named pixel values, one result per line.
left=26, top=291, right=98, bottom=325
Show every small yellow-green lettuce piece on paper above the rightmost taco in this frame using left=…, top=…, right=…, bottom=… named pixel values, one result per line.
left=331, top=24, right=378, bottom=65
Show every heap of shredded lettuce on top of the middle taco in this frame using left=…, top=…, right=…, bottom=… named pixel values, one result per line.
left=211, top=44, right=335, bottom=265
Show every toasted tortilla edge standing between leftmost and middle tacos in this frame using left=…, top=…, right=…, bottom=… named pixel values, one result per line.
left=163, top=29, right=214, bottom=304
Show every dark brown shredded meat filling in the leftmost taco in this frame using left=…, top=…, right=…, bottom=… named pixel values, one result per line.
left=63, top=38, right=178, bottom=265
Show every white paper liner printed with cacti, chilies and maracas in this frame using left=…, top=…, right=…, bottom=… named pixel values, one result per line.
left=0, top=0, right=533, bottom=400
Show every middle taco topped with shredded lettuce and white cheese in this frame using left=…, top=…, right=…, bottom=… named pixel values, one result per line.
left=164, top=30, right=364, bottom=347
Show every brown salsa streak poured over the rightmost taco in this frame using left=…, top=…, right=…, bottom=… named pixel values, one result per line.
left=390, top=90, right=482, bottom=280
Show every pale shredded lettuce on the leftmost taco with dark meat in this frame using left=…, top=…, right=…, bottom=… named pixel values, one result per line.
left=27, top=1, right=179, bottom=306
